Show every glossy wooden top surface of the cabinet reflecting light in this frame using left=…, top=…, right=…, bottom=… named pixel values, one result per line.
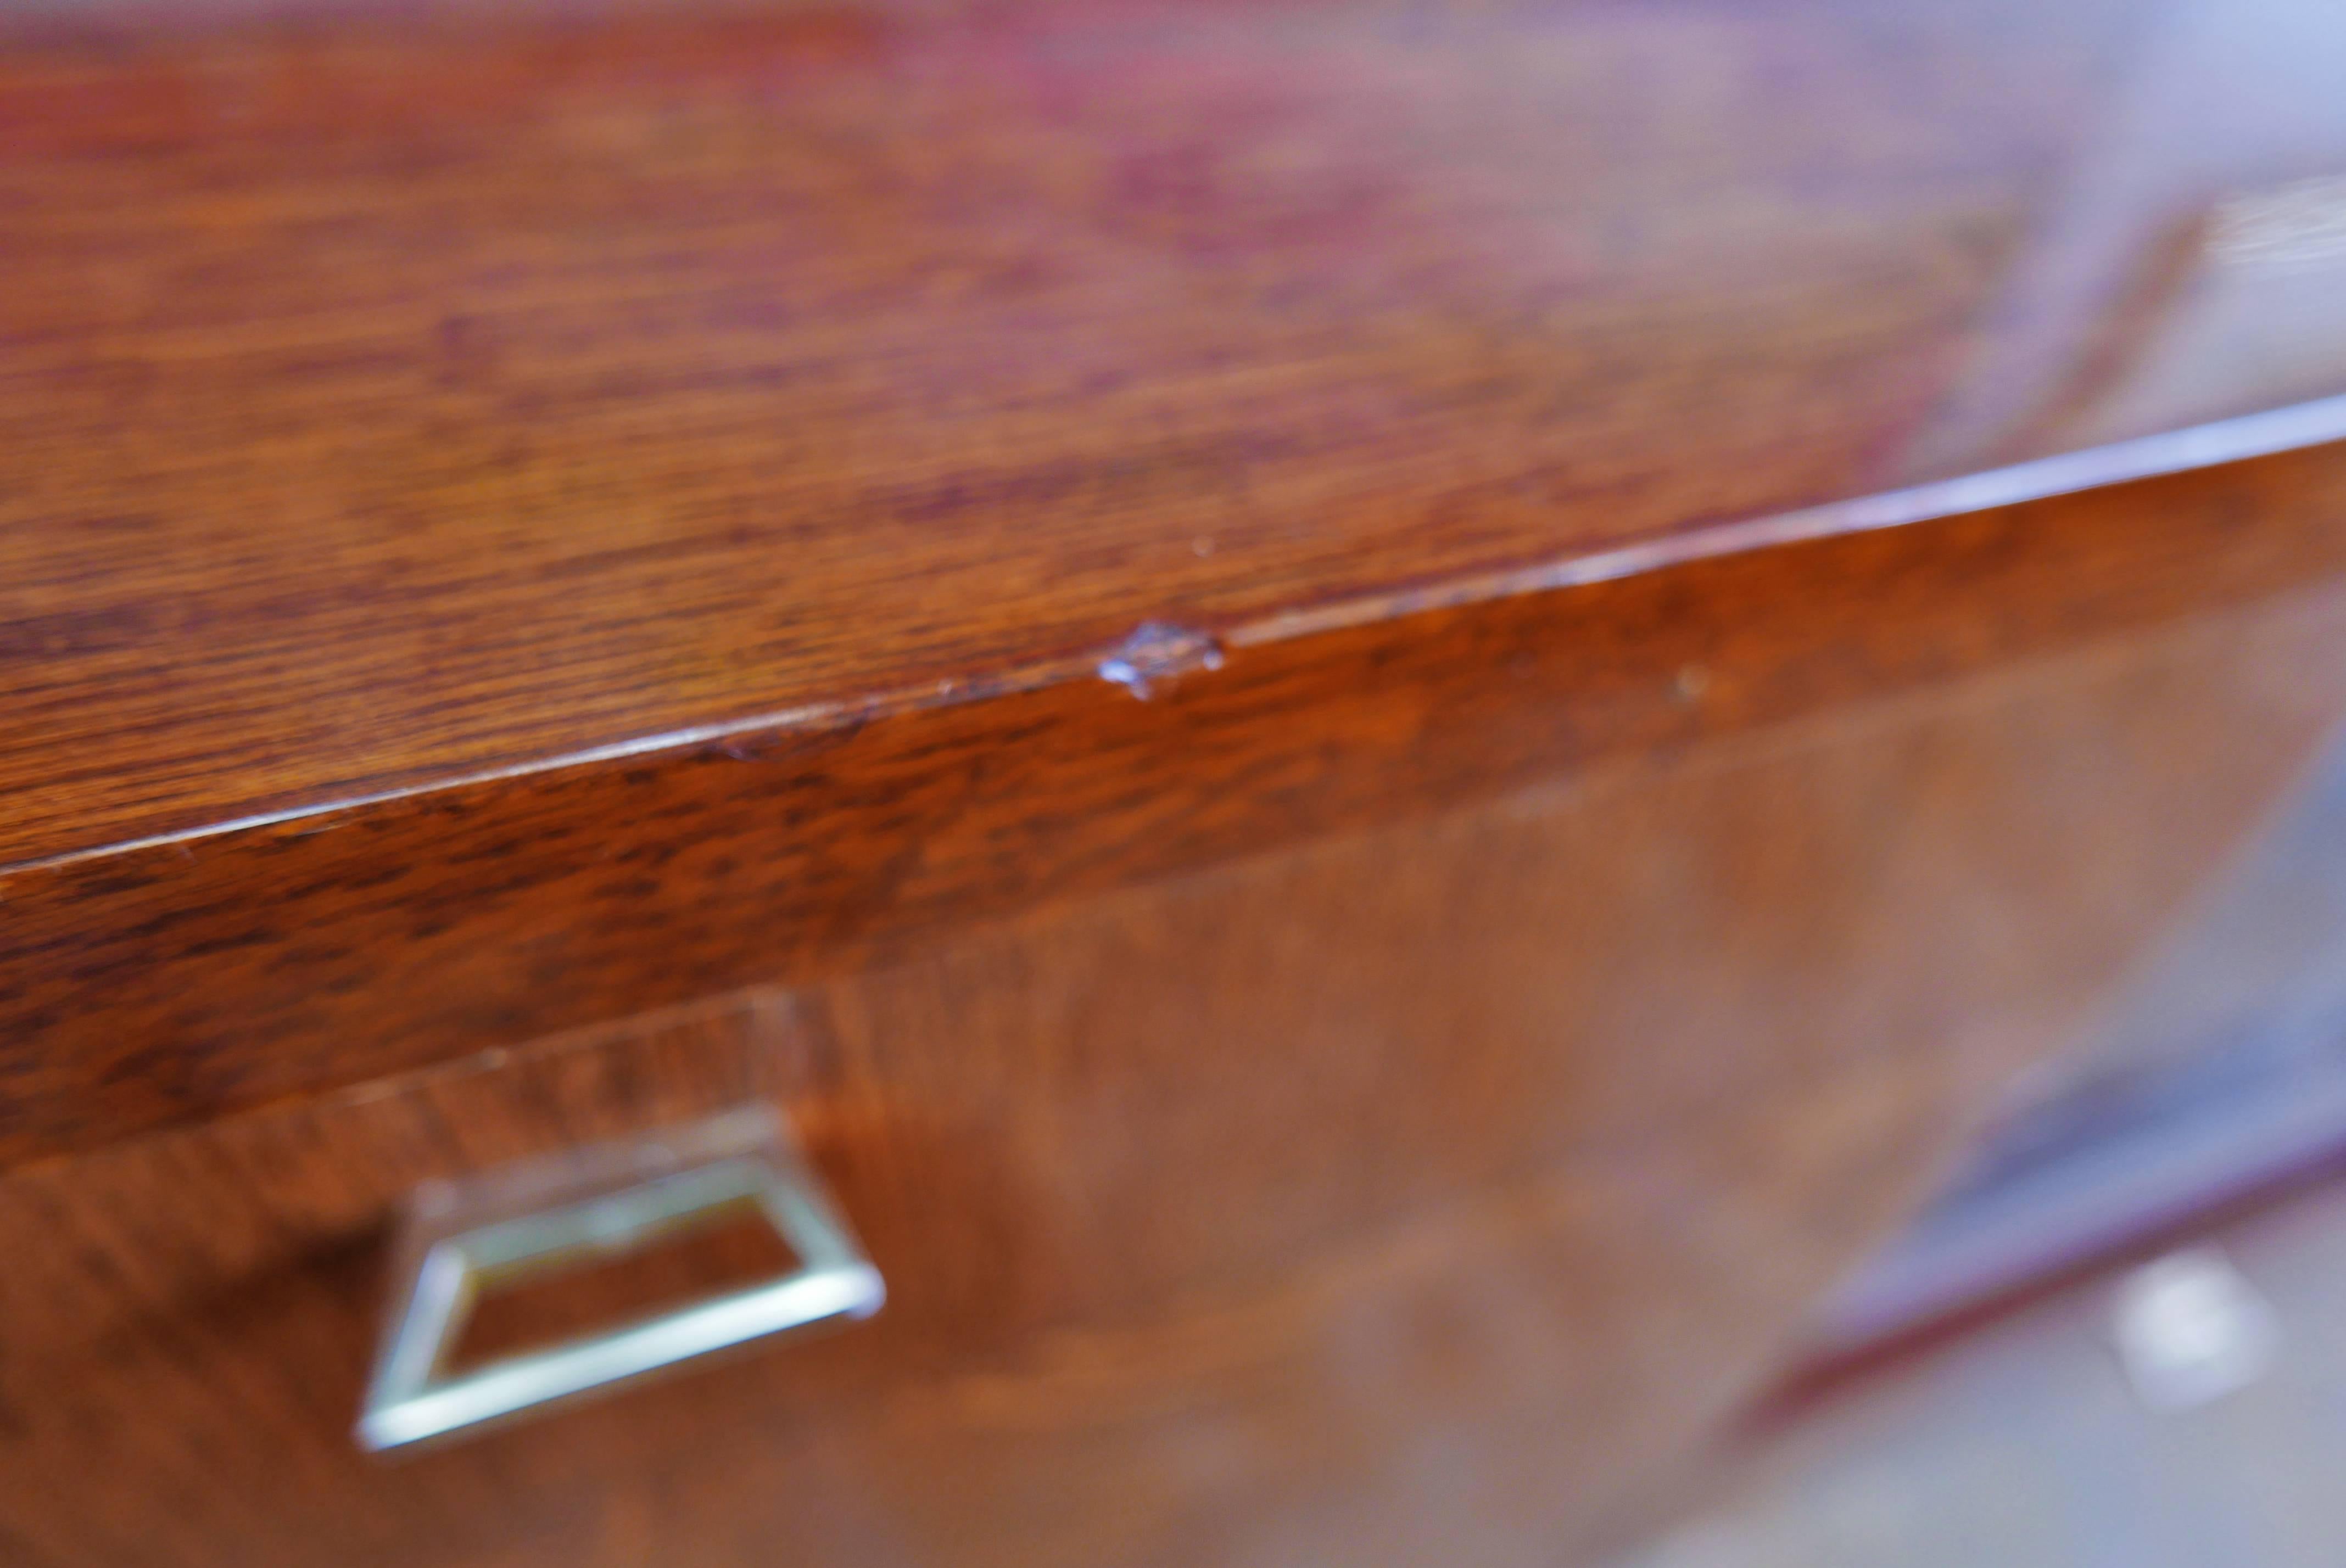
left=18, top=0, right=2346, bottom=867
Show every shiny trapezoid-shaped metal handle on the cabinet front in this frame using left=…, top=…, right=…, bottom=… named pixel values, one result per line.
left=356, top=1106, right=887, bottom=1451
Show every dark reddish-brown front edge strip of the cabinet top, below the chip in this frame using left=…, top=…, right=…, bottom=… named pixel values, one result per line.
left=0, top=433, right=2346, bottom=1162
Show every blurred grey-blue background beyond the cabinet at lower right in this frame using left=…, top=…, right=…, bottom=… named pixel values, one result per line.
left=1612, top=726, right=2346, bottom=1568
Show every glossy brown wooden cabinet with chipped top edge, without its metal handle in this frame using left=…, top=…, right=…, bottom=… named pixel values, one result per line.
left=0, top=0, right=2346, bottom=1566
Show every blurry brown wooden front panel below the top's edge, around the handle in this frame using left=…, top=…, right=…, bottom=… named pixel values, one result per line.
left=14, top=548, right=2346, bottom=1568
